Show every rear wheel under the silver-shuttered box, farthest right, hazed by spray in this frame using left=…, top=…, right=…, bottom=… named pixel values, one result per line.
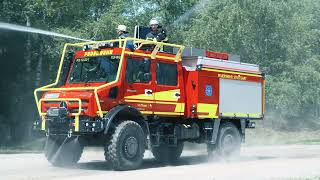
left=216, top=122, right=241, bottom=160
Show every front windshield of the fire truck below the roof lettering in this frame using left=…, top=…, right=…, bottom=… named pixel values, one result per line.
left=68, top=55, right=120, bottom=83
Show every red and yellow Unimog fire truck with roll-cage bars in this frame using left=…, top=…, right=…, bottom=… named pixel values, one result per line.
left=34, top=38, right=264, bottom=170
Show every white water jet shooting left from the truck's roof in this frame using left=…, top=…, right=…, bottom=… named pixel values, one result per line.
left=0, top=22, right=91, bottom=42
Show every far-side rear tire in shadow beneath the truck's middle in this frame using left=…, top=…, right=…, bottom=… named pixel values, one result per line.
left=151, top=142, right=183, bottom=164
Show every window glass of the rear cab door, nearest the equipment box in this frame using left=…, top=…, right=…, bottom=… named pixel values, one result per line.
left=157, top=62, right=178, bottom=86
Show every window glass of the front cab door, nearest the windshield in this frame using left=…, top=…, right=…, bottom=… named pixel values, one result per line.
left=126, top=58, right=151, bottom=83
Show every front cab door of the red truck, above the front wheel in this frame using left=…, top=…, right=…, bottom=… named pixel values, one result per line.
left=124, top=57, right=154, bottom=114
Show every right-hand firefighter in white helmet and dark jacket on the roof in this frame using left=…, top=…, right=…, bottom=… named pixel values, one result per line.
left=146, top=19, right=168, bottom=42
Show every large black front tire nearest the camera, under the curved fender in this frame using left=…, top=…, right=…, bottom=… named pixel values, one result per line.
left=104, top=120, right=146, bottom=171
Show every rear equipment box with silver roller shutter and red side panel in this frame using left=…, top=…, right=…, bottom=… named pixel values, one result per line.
left=182, top=56, right=264, bottom=119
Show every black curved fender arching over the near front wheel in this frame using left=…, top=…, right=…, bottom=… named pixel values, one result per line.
left=103, top=105, right=149, bottom=135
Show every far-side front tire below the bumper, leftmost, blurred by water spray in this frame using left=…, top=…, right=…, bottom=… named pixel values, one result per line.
left=44, top=136, right=83, bottom=166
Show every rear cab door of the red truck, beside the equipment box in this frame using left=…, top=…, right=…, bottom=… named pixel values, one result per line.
left=153, top=60, right=184, bottom=116
